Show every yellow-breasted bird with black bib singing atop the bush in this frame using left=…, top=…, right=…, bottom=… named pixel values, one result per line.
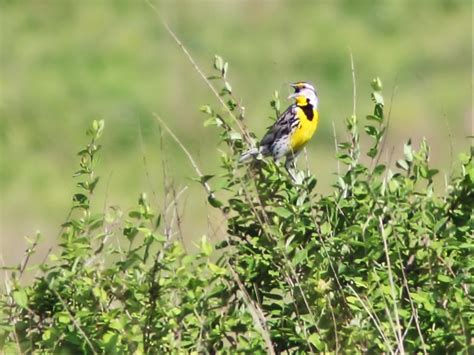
left=239, top=81, right=319, bottom=181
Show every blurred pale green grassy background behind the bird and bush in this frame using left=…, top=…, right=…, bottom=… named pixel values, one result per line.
left=0, top=0, right=472, bottom=264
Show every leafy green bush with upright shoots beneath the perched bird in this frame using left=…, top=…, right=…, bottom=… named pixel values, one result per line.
left=0, top=57, right=474, bottom=353
